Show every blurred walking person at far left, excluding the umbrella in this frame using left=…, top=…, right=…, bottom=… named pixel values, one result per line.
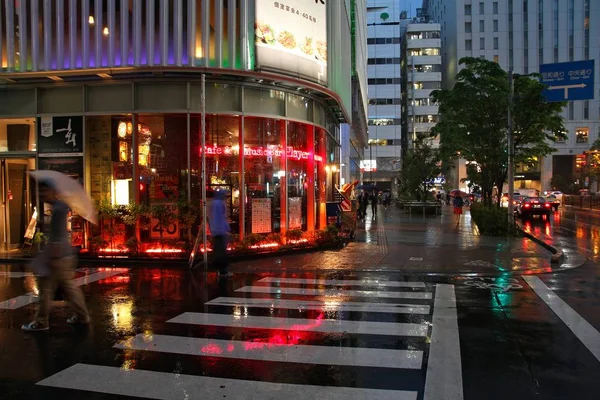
left=21, top=181, right=90, bottom=332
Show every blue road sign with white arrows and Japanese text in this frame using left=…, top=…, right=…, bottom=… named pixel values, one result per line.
left=540, top=60, right=595, bottom=101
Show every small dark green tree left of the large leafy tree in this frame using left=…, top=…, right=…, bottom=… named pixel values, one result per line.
left=401, top=134, right=440, bottom=200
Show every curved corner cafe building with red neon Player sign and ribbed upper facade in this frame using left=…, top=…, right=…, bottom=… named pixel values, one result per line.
left=0, top=0, right=351, bottom=249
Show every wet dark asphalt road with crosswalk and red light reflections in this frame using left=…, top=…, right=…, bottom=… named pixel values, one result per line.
left=0, top=208, right=600, bottom=400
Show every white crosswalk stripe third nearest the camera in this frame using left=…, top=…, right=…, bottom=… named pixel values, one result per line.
left=167, top=312, right=429, bottom=336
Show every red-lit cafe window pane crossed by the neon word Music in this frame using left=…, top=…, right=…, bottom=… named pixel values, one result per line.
left=244, top=118, right=286, bottom=233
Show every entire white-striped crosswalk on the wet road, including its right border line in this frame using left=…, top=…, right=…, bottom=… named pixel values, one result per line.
left=38, top=277, right=463, bottom=400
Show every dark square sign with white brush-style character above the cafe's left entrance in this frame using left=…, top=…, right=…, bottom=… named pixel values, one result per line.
left=37, top=117, right=83, bottom=157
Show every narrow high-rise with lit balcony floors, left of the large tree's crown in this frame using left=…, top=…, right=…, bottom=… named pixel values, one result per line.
left=402, top=19, right=442, bottom=155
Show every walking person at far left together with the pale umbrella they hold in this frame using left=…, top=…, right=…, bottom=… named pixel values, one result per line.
left=21, top=171, right=97, bottom=332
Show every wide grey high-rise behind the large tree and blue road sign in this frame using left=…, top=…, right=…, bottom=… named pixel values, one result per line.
left=423, top=0, right=600, bottom=190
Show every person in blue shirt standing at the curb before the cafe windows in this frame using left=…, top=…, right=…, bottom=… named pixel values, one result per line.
left=208, top=190, right=233, bottom=277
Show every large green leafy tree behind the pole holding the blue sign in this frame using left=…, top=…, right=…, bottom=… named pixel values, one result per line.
left=431, top=57, right=565, bottom=205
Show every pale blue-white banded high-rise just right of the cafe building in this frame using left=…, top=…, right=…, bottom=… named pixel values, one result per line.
left=362, top=0, right=409, bottom=189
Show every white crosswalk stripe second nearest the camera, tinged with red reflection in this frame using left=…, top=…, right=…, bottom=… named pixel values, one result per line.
left=114, top=334, right=423, bottom=369
